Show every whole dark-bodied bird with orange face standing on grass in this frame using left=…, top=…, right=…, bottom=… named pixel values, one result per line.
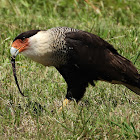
left=10, top=27, right=140, bottom=106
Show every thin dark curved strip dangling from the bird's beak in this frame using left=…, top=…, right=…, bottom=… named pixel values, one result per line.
left=11, top=56, right=27, bottom=97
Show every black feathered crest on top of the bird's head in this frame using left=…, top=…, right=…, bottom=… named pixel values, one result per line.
left=13, top=30, right=40, bottom=42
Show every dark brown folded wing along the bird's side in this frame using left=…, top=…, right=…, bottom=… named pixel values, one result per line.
left=66, top=31, right=139, bottom=85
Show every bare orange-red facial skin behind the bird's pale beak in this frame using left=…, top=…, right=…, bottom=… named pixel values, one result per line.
left=12, top=38, right=29, bottom=52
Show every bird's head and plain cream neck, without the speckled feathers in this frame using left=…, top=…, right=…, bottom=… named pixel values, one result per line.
left=10, top=30, right=57, bottom=66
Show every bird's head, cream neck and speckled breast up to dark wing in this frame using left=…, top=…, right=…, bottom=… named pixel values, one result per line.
left=10, top=28, right=67, bottom=66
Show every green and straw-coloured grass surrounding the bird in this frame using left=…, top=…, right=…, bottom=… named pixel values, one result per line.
left=0, top=0, right=140, bottom=140
